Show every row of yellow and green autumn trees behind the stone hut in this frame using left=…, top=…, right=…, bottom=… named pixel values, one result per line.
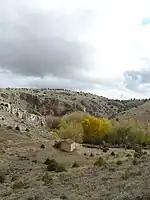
left=54, top=112, right=150, bottom=146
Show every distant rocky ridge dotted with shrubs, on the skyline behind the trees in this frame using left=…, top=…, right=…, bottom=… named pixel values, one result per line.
left=0, top=88, right=149, bottom=118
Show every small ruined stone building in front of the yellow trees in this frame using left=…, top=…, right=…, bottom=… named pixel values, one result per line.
left=60, top=139, right=76, bottom=152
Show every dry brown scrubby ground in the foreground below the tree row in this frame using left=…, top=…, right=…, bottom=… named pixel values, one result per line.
left=0, top=128, right=150, bottom=200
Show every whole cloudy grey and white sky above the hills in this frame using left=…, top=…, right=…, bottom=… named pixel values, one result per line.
left=0, top=0, right=150, bottom=99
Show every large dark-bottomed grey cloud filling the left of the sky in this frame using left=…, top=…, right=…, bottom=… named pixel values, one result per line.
left=0, top=1, right=93, bottom=78
